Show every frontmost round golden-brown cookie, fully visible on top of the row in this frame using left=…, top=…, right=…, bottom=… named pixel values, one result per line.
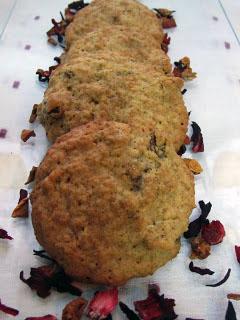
left=31, top=122, right=194, bottom=285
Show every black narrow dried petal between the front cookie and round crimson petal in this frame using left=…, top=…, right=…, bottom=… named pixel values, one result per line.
left=184, top=201, right=212, bottom=239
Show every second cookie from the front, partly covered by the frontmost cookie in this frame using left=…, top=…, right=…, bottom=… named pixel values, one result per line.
left=38, top=56, right=188, bottom=150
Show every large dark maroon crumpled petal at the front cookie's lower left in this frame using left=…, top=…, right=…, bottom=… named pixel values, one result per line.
left=20, top=263, right=82, bottom=298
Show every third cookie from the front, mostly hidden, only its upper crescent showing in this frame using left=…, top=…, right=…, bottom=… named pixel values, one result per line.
left=61, top=26, right=172, bottom=74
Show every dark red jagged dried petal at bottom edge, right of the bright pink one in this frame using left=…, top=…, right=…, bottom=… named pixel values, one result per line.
left=134, top=285, right=177, bottom=320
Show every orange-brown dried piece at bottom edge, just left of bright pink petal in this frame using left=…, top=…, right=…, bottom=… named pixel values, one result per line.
left=62, top=298, right=87, bottom=320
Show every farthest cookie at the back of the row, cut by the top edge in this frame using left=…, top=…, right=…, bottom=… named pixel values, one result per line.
left=66, top=0, right=164, bottom=47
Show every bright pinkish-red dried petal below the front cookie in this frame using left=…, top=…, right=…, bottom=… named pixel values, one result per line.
left=87, top=288, right=118, bottom=319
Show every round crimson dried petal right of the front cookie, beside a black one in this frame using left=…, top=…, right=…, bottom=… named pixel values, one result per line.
left=202, top=220, right=225, bottom=246
